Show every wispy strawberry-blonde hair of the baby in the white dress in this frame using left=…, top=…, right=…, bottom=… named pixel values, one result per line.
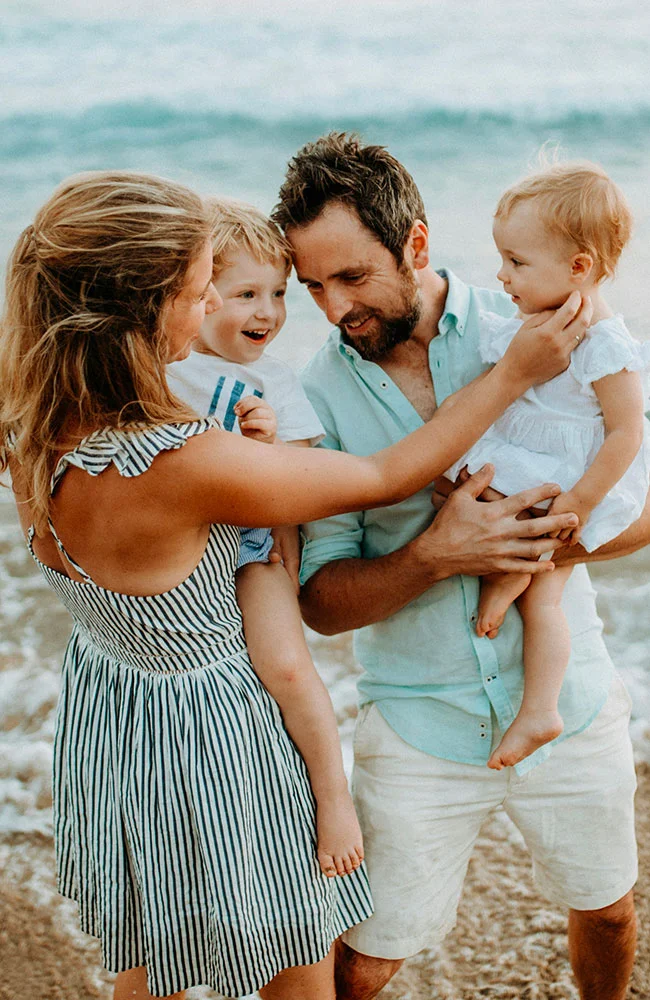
left=494, top=162, right=632, bottom=281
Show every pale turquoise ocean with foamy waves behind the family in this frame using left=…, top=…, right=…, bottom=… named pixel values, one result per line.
left=0, top=0, right=650, bottom=992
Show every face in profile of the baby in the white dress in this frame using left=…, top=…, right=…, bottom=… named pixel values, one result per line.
left=492, top=199, right=577, bottom=314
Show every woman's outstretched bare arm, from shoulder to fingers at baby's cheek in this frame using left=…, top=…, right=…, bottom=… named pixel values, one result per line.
left=175, top=295, right=590, bottom=527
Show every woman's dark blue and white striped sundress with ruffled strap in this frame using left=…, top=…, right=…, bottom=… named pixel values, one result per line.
left=25, top=419, right=372, bottom=997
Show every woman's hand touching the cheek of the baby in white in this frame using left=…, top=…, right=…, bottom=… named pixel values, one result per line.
left=497, top=292, right=594, bottom=392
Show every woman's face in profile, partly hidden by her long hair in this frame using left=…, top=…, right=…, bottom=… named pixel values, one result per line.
left=163, top=240, right=222, bottom=361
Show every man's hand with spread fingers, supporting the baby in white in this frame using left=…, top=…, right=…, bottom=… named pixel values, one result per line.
left=420, top=465, right=578, bottom=582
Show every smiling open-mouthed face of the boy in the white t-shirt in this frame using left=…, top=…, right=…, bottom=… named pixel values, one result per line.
left=195, top=251, right=287, bottom=364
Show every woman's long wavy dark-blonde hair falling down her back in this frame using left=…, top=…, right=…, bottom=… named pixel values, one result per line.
left=0, top=171, right=211, bottom=529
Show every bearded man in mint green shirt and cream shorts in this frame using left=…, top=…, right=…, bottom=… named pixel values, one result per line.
left=274, top=134, right=636, bottom=1000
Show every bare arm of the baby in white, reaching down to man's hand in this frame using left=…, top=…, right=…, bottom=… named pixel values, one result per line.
left=549, top=371, right=644, bottom=544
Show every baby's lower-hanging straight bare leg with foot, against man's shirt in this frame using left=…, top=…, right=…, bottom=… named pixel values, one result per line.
left=488, top=566, right=571, bottom=770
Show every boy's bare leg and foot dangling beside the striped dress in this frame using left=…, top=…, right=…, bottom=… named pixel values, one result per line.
left=236, top=563, right=363, bottom=875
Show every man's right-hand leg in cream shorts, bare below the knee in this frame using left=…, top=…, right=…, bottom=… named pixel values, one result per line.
left=504, top=675, right=637, bottom=1000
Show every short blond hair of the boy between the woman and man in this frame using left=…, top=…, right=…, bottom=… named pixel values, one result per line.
left=206, top=198, right=292, bottom=278
